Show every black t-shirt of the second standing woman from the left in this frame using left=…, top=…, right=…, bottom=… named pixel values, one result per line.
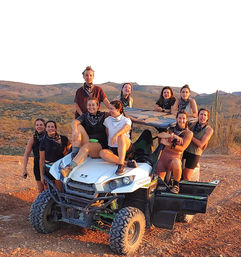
left=39, top=135, right=69, bottom=162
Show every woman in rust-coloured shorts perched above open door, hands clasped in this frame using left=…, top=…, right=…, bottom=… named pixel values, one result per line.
left=156, top=111, right=193, bottom=194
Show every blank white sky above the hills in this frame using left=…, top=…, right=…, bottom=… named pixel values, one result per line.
left=0, top=0, right=241, bottom=93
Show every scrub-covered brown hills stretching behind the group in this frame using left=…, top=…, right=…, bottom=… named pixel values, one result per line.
left=0, top=81, right=241, bottom=154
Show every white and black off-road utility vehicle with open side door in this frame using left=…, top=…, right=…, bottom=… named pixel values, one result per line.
left=30, top=109, right=218, bottom=254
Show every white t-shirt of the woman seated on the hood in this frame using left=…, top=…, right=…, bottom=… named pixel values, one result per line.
left=104, top=114, right=131, bottom=147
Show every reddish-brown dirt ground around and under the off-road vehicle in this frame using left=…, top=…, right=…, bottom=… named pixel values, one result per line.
left=0, top=155, right=241, bottom=257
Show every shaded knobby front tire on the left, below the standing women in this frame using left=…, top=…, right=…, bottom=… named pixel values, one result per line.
left=29, top=190, right=61, bottom=234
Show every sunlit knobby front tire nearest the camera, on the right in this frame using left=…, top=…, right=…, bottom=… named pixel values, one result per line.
left=110, top=207, right=146, bottom=254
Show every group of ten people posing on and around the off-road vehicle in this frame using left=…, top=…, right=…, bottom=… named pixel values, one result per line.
left=23, top=66, right=213, bottom=193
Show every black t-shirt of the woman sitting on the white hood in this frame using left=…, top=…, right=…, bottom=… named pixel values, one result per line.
left=77, top=111, right=107, bottom=147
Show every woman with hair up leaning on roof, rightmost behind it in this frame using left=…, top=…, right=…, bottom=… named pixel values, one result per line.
left=172, top=85, right=198, bottom=118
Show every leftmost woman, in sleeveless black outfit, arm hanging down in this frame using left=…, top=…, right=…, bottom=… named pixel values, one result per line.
left=23, top=118, right=45, bottom=193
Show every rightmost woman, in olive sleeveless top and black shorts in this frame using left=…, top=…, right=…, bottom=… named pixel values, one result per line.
left=183, top=108, right=213, bottom=181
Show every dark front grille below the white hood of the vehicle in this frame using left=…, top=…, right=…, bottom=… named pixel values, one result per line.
left=66, top=179, right=96, bottom=198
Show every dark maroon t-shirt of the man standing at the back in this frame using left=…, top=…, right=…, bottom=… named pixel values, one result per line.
left=74, top=86, right=107, bottom=118
